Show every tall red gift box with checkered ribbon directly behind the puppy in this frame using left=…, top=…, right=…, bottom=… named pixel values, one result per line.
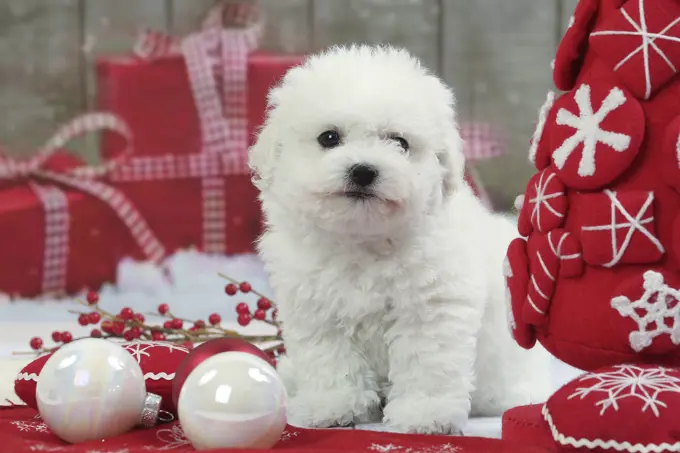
left=97, top=2, right=261, bottom=254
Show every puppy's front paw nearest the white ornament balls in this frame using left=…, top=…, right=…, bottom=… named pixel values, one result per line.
left=288, top=388, right=381, bottom=428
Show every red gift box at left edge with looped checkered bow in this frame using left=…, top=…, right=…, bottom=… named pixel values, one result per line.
left=0, top=114, right=165, bottom=297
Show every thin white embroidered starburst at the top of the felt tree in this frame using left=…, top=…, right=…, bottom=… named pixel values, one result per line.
left=590, top=0, right=680, bottom=99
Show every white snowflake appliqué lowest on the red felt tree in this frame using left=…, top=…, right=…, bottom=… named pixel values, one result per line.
left=611, top=271, right=680, bottom=352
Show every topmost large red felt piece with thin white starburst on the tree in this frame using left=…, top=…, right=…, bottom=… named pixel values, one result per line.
left=589, top=0, right=680, bottom=99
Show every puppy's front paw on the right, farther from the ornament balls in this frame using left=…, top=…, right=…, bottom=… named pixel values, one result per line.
left=384, top=394, right=470, bottom=435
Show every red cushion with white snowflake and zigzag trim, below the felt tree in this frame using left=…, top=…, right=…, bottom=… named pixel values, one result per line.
left=543, top=365, right=680, bottom=453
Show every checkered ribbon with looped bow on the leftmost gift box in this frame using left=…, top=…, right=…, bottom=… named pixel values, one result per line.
left=0, top=113, right=165, bottom=293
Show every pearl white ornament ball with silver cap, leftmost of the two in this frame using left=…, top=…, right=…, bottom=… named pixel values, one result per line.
left=36, top=338, right=146, bottom=443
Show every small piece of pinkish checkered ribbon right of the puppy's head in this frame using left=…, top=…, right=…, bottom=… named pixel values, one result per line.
left=460, top=122, right=507, bottom=207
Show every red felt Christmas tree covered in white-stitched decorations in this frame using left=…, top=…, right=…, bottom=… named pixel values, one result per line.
left=508, top=0, right=680, bottom=370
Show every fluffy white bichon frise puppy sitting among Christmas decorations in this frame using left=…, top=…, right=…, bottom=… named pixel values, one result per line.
left=250, top=46, right=550, bottom=433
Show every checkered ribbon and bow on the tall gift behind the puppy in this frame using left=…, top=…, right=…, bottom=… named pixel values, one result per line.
left=132, top=2, right=263, bottom=253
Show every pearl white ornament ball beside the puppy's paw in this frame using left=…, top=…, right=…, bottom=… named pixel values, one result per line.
left=177, top=351, right=288, bottom=450
